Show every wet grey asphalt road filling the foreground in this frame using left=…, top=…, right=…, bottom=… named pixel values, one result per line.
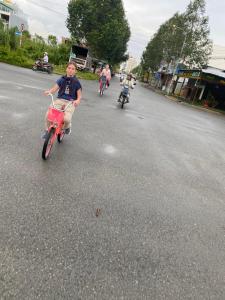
left=0, top=64, right=225, bottom=300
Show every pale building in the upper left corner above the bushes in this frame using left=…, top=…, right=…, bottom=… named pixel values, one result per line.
left=0, top=0, right=28, bottom=30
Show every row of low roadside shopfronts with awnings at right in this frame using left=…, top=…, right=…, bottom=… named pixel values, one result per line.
left=149, top=45, right=225, bottom=110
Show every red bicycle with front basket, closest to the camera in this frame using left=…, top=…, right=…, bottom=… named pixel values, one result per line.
left=42, top=94, right=72, bottom=160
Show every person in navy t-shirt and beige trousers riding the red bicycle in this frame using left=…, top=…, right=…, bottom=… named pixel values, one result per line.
left=42, top=62, right=82, bottom=139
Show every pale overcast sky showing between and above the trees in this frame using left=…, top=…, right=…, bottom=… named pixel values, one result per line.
left=14, top=0, right=225, bottom=59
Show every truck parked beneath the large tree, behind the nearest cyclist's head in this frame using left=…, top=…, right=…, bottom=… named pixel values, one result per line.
left=69, top=45, right=92, bottom=70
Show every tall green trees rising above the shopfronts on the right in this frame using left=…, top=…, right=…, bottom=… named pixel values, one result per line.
left=142, top=0, right=212, bottom=71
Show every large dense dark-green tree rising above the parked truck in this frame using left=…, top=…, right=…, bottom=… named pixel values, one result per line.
left=67, top=0, right=130, bottom=64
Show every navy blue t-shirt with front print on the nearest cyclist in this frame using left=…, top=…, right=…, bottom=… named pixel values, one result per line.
left=56, top=76, right=82, bottom=101
